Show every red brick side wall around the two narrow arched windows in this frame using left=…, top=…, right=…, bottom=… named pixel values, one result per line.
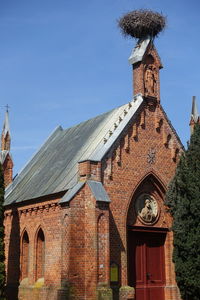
left=5, top=199, right=62, bottom=300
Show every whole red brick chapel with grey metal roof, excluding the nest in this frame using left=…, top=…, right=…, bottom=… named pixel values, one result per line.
left=1, top=38, right=186, bottom=300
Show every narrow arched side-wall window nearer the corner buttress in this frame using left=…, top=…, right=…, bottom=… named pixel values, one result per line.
left=36, top=228, right=45, bottom=280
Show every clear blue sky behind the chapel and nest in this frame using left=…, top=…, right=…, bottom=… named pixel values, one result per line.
left=0, top=0, right=200, bottom=173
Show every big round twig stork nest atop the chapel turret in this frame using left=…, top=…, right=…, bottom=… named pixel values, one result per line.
left=118, top=9, right=166, bottom=39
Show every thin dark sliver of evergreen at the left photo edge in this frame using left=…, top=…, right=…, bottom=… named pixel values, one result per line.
left=0, top=165, right=5, bottom=299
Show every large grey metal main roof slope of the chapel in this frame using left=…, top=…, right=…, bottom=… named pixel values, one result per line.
left=5, top=95, right=143, bottom=205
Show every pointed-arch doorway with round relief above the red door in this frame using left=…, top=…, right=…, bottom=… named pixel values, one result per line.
left=127, top=175, right=168, bottom=300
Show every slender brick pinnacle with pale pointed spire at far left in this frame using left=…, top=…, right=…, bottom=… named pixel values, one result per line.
left=0, top=108, right=13, bottom=187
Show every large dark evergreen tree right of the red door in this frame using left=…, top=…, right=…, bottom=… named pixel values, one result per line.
left=166, top=124, right=200, bottom=300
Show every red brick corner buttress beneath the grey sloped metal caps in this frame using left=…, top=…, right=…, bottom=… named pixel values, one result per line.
left=57, top=184, right=110, bottom=299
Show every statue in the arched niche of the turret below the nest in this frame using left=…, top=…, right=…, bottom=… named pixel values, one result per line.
left=144, top=64, right=157, bottom=97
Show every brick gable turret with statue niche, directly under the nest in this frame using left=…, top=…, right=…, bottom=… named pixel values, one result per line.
left=129, top=36, right=162, bottom=103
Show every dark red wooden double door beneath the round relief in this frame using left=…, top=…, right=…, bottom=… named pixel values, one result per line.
left=129, top=231, right=166, bottom=300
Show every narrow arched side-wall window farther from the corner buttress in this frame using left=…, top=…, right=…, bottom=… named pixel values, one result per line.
left=21, top=231, right=29, bottom=279
